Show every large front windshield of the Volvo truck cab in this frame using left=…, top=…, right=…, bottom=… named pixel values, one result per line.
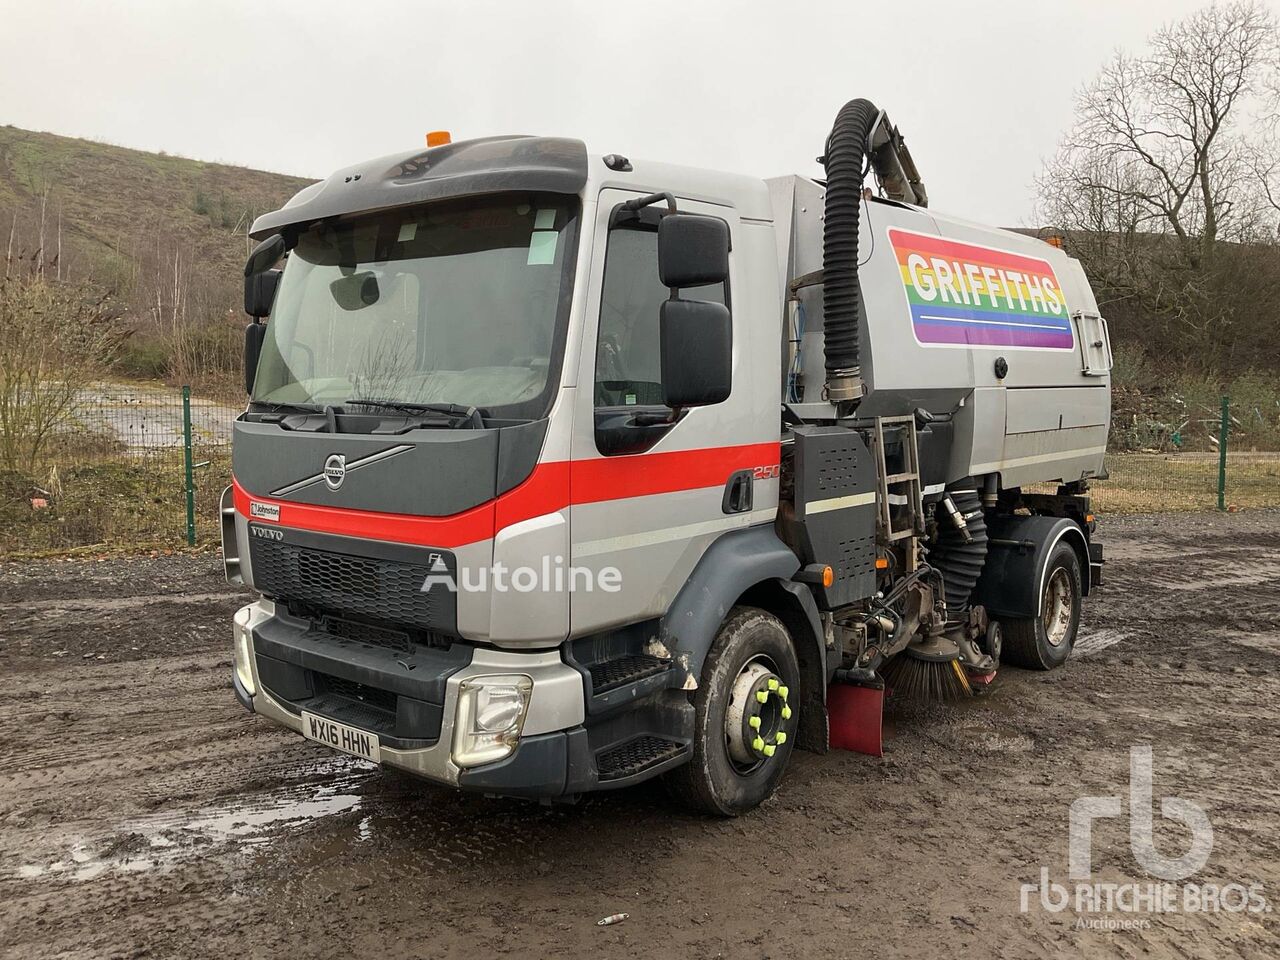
left=253, top=195, right=577, bottom=419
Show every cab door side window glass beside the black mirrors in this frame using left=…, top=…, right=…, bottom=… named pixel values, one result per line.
left=595, top=225, right=726, bottom=414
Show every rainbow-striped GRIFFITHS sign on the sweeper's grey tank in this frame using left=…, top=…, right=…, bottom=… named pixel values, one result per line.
left=888, top=229, right=1075, bottom=349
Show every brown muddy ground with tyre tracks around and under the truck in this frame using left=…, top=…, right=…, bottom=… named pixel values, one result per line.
left=0, top=512, right=1280, bottom=960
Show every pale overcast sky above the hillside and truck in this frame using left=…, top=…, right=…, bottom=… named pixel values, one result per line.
left=0, top=0, right=1280, bottom=224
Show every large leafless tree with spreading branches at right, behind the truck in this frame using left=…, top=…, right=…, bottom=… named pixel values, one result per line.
left=1038, top=0, right=1280, bottom=362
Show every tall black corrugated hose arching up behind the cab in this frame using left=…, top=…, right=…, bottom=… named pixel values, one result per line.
left=822, top=100, right=879, bottom=403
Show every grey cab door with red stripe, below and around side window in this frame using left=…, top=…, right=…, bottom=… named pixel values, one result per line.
left=570, top=189, right=781, bottom=636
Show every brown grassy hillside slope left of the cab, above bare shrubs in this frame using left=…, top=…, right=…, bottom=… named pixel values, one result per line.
left=0, top=127, right=307, bottom=288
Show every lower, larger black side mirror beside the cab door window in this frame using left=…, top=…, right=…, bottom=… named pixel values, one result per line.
left=658, top=299, right=733, bottom=408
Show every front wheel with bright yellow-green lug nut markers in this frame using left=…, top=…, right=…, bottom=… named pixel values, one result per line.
left=667, top=607, right=800, bottom=817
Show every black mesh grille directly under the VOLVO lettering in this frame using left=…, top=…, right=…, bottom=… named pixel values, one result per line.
left=250, top=539, right=453, bottom=627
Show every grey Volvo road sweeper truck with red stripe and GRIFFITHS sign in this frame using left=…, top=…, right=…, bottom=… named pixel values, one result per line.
left=223, top=101, right=1110, bottom=814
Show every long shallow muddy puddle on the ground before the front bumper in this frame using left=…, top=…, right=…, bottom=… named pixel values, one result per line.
left=17, top=756, right=372, bottom=881
